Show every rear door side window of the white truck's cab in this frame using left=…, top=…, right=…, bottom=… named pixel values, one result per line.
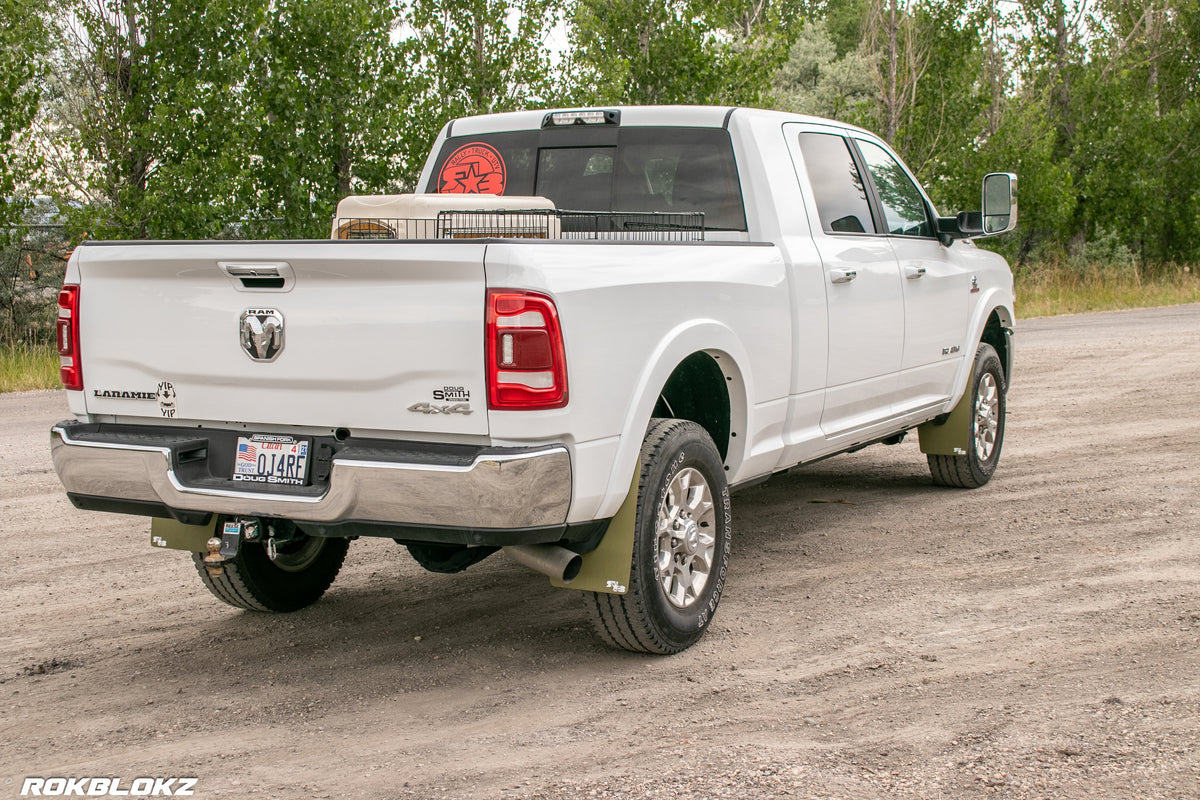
left=799, top=133, right=875, bottom=234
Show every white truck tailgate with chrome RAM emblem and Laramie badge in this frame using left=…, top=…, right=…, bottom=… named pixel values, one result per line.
left=77, top=241, right=487, bottom=435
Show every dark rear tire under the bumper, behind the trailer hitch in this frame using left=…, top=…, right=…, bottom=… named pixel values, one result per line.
left=192, top=525, right=350, bottom=612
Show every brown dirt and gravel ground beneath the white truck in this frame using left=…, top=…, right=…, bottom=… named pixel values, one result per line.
left=0, top=306, right=1200, bottom=800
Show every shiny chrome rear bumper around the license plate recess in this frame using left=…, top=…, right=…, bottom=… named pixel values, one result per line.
left=50, top=423, right=571, bottom=530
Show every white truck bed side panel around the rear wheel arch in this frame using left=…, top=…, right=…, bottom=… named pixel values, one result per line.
left=486, top=242, right=791, bottom=522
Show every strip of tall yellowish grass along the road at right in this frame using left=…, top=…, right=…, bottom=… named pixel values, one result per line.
left=1016, top=261, right=1200, bottom=317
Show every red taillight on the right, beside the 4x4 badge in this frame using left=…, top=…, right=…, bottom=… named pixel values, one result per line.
left=486, top=289, right=566, bottom=410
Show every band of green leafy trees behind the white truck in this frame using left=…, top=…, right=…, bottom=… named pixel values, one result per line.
left=11, top=0, right=1200, bottom=272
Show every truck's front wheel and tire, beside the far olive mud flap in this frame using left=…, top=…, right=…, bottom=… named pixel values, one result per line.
left=928, top=344, right=1008, bottom=489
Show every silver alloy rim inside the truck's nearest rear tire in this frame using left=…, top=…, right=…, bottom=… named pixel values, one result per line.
left=654, top=467, right=716, bottom=608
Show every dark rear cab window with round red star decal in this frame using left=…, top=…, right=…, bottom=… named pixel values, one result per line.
left=425, top=126, right=746, bottom=230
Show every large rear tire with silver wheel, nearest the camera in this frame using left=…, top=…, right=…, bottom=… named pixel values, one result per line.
left=584, top=419, right=731, bottom=655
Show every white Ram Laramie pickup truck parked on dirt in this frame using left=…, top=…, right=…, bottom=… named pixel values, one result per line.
left=52, top=107, right=1016, bottom=654
